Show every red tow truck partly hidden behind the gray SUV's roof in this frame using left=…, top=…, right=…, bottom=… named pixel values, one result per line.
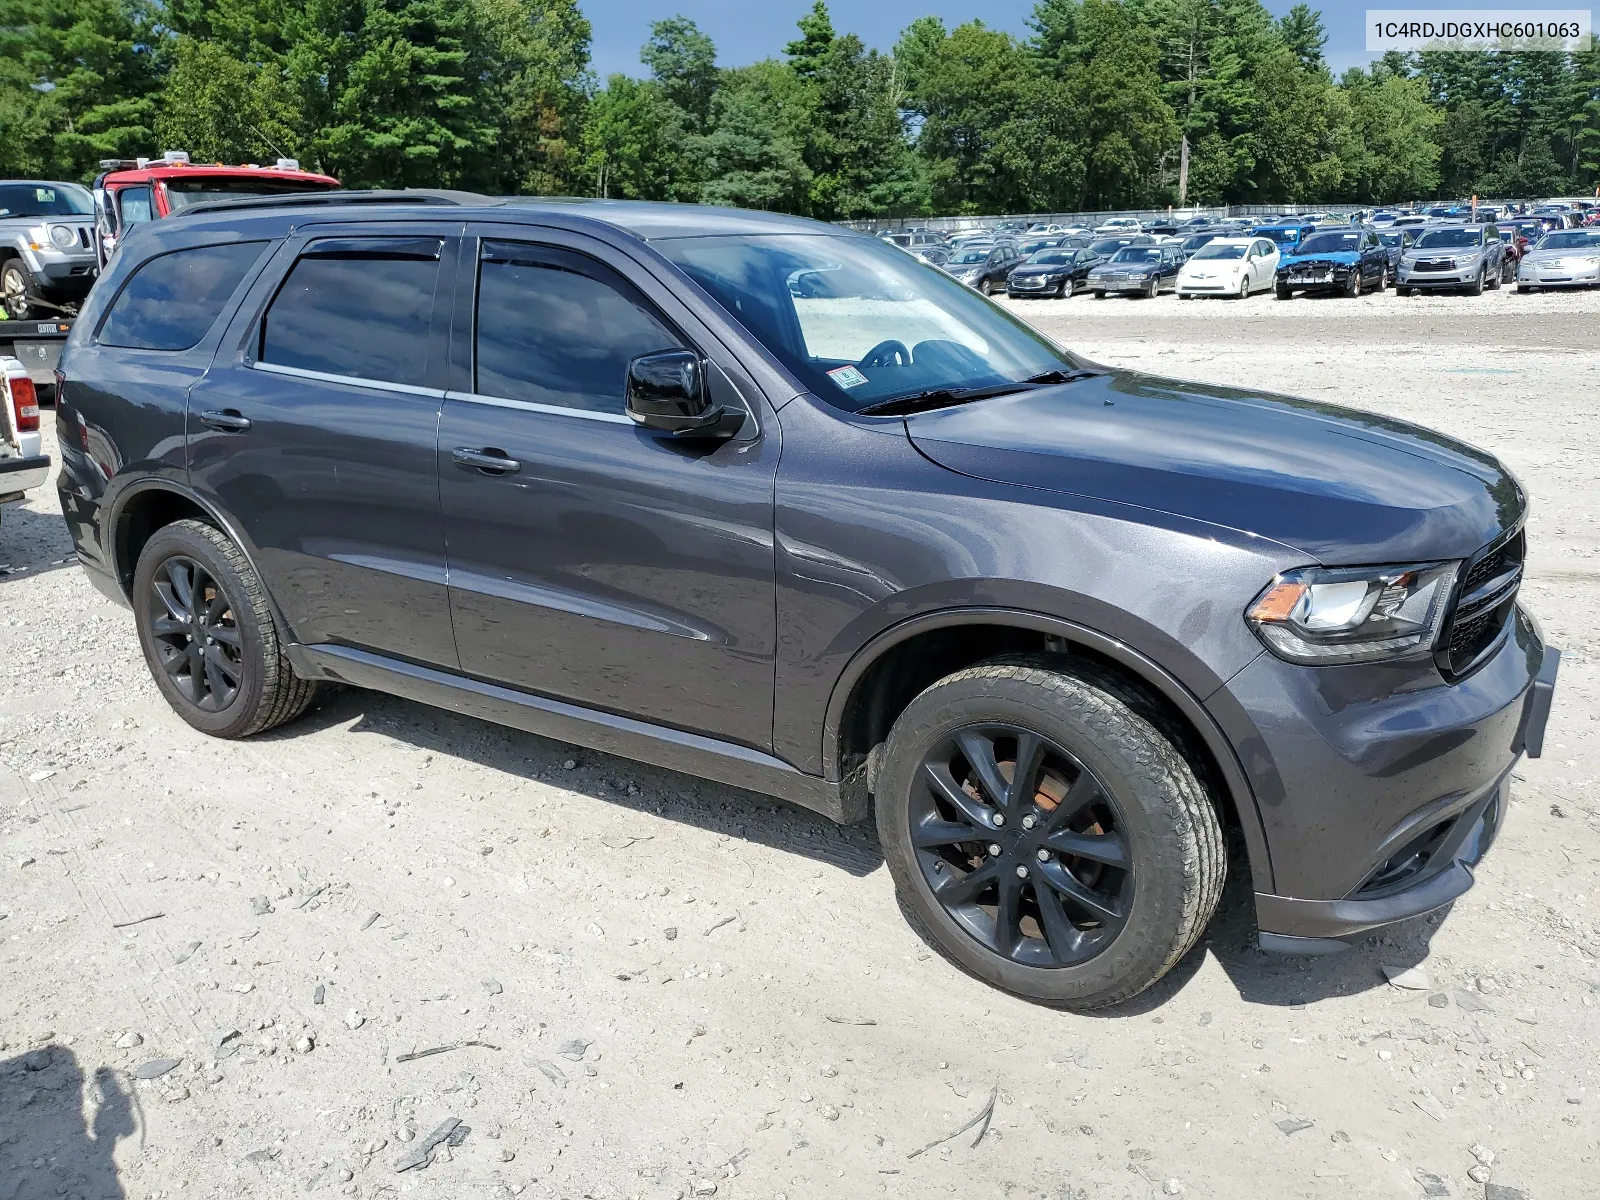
left=94, top=150, right=339, bottom=266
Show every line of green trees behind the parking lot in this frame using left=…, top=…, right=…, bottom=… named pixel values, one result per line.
left=0, top=0, right=1600, bottom=219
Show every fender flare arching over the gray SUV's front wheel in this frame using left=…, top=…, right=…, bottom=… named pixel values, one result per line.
left=822, top=606, right=1272, bottom=891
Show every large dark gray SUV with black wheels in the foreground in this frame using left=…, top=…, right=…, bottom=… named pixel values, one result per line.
left=56, top=194, right=1557, bottom=1008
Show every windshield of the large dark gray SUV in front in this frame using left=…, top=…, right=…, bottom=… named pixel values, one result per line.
left=653, top=234, right=1077, bottom=411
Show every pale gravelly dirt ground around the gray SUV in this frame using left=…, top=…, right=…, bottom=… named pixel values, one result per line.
left=0, top=291, right=1600, bottom=1200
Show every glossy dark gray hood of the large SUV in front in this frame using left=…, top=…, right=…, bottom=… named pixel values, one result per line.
left=906, top=371, right=1525, bottom=565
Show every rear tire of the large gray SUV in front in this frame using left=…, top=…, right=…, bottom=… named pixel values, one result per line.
left=133, top=520, right=317, bottom=738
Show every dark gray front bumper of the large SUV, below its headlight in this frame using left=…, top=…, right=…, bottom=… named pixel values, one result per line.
left=1208, top=610, right=1560, bottom=954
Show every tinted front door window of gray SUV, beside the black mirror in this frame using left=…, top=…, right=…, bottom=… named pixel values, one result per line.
left=477, top=242, right=678, bottom=413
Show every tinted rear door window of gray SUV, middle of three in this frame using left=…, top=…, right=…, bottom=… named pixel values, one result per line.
left=261, top=238, right=443, bottom=387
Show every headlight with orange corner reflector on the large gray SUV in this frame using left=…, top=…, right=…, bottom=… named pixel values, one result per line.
left=1245, top=563, right=1459, bottom=664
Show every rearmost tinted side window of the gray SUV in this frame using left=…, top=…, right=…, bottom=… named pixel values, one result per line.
left=99, top=242, right=267, bottom=350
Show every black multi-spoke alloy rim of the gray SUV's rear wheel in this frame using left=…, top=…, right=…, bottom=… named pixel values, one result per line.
left=144, top=554, right=245, bottom=712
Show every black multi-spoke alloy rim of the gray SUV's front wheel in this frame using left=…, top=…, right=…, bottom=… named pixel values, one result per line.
left=909, top=723, right=1134, bottom=966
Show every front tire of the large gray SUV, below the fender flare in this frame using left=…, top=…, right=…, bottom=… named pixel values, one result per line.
left=875, top=656, right=1227, bottom=1010
